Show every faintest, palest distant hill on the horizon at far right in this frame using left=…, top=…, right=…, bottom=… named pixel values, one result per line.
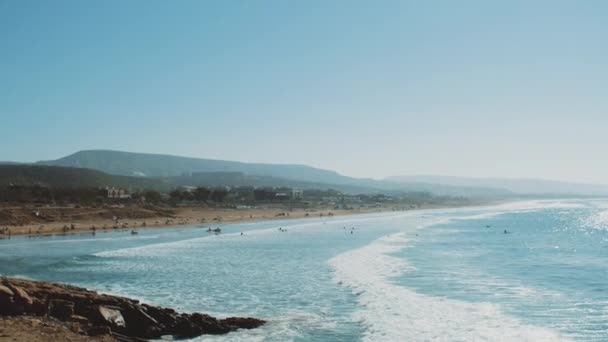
left=386, top=175, right=608, bottom=196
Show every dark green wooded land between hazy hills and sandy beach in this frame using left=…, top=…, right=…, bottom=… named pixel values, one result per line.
left=0, top=165, right=470, bottom=209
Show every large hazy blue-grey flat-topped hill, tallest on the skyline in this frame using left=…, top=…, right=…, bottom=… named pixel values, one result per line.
left=39, top=150, right=511, bottom=198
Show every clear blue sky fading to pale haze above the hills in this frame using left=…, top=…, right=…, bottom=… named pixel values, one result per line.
left=0, top=0, right=608, bottom=183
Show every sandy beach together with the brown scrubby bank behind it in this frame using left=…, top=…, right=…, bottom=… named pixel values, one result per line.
left=0, top=207, right=408, bottom=239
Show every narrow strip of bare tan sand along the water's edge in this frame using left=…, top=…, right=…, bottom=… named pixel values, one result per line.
left=0, top=204, right=476, bottom=240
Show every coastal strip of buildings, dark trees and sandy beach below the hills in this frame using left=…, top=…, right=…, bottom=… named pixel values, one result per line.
left=0, top=184, right=446, bottom=238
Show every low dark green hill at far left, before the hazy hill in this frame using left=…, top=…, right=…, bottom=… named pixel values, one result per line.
left=0, top=165, right=168, bottom=190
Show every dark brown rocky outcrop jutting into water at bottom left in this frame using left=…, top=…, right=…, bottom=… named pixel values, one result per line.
left=0, top=277, right=265, bottom=341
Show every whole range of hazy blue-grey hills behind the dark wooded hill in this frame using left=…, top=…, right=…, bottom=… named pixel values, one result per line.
left=0, top=150, right=608, bottom=198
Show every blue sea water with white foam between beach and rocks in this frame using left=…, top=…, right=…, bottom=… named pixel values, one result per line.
left=0, top=200, right=608, bottom=341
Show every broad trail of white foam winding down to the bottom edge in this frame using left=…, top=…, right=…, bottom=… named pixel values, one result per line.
left=329, top=233, right=566, bottom=341
